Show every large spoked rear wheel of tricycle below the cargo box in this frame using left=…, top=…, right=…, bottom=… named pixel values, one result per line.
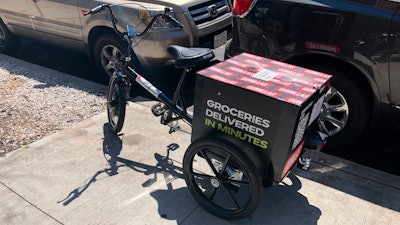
left=183, top=139, right=262, bottom=220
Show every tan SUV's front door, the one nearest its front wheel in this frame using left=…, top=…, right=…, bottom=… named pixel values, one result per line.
left=27, top=0, right=82, bottom=40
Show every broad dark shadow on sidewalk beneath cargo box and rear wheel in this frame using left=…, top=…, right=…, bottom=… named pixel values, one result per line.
left=150, top=174, right=321, bottom=225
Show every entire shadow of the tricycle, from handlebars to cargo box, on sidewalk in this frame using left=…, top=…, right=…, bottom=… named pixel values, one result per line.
left=57, top=123, right=321, bottom=225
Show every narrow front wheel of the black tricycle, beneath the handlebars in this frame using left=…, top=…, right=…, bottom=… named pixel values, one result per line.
left=107, top=78, right=127, bottom=134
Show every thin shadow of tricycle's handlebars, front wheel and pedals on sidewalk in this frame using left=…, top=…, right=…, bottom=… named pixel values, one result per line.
left=57, top=123, right=183, bottom=206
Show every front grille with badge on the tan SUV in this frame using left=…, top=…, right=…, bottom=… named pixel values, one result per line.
left=189, top=0, right=231, bottom=26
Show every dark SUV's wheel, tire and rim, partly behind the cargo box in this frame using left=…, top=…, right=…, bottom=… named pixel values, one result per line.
left=309, top=66, right=370, bottom=152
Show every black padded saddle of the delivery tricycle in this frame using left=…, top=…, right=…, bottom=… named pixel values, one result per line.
left=167, top=45, right=215, bottom=68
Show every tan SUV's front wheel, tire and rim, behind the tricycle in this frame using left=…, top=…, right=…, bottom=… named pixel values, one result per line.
left=93, top=34, right=140, bottom=83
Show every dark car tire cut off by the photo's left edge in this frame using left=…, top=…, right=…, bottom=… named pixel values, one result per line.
left=0, top=19, right=21, bottom=55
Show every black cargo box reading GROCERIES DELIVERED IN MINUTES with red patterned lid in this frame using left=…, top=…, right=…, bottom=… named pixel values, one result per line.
left=191, top=53, right=331, bottom=182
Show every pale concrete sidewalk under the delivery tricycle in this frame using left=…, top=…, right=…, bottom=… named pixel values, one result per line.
left=0, top=101, right=400, bottom=225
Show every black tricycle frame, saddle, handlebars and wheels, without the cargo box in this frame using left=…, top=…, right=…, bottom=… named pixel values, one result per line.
left=85, top=4, right=328, bottom=219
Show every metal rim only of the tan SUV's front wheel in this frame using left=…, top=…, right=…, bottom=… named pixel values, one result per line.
left=101, top=45, right=122, bottom=76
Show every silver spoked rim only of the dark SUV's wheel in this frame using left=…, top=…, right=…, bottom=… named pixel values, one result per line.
left=318, top=87, right=349, bottom=136
